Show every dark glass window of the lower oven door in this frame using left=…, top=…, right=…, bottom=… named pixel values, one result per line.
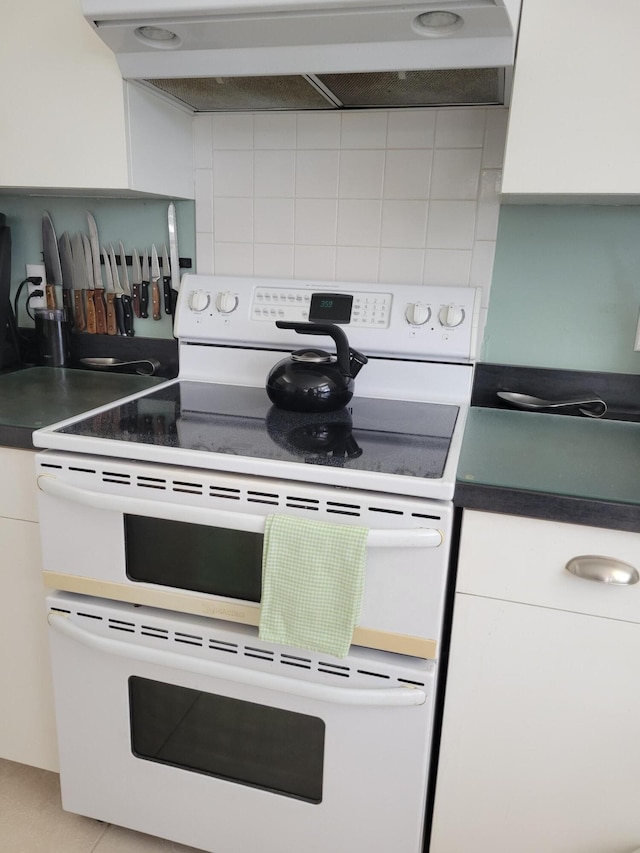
left=129, top=676, right=325, bottom=803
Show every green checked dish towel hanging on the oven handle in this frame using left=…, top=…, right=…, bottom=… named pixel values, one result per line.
left=260, top=515, right=368, bottom=658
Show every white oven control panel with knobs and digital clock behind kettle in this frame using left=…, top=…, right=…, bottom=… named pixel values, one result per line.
left=174, top=274, right=480, bottom=361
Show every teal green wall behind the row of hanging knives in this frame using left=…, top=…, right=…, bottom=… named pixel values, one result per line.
left=0, top=196, right=195, bottom=338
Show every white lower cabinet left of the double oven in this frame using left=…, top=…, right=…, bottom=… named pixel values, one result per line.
left=0, top=448, right=58, bottom=771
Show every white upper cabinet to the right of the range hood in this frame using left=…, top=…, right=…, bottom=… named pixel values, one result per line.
left=502, top=0, right=640, bottom=204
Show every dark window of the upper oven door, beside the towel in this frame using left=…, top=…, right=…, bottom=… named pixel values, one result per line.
left=124, top=515, right=263, bottom=601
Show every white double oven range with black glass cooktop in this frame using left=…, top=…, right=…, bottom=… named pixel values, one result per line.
left=34, top=275, right=478, bottom=853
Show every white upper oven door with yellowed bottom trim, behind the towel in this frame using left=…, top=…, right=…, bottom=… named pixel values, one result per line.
left=38, top=452, right=452, bottom=658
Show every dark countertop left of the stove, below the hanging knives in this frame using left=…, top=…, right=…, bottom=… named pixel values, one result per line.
left=0, top=367, right=166, bottom=448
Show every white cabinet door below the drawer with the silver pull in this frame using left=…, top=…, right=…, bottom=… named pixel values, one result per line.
left=430, top=594, right=640, bottom=853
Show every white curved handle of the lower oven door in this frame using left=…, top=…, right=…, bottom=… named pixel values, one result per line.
left=47, top=611, right=427, bottom=707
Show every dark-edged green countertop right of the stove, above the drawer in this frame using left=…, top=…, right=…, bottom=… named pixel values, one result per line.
left=454, top=406, right=640, bottom=532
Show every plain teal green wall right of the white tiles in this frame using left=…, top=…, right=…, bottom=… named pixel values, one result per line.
left=481, top=205, right=640, bottom=373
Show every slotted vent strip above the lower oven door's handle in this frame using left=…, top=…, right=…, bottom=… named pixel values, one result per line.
left=51, top=607, right=426, bottom=687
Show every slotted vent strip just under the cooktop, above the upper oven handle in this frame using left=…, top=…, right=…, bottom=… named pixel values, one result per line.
left=41, top=462, right=442, bottom=522
